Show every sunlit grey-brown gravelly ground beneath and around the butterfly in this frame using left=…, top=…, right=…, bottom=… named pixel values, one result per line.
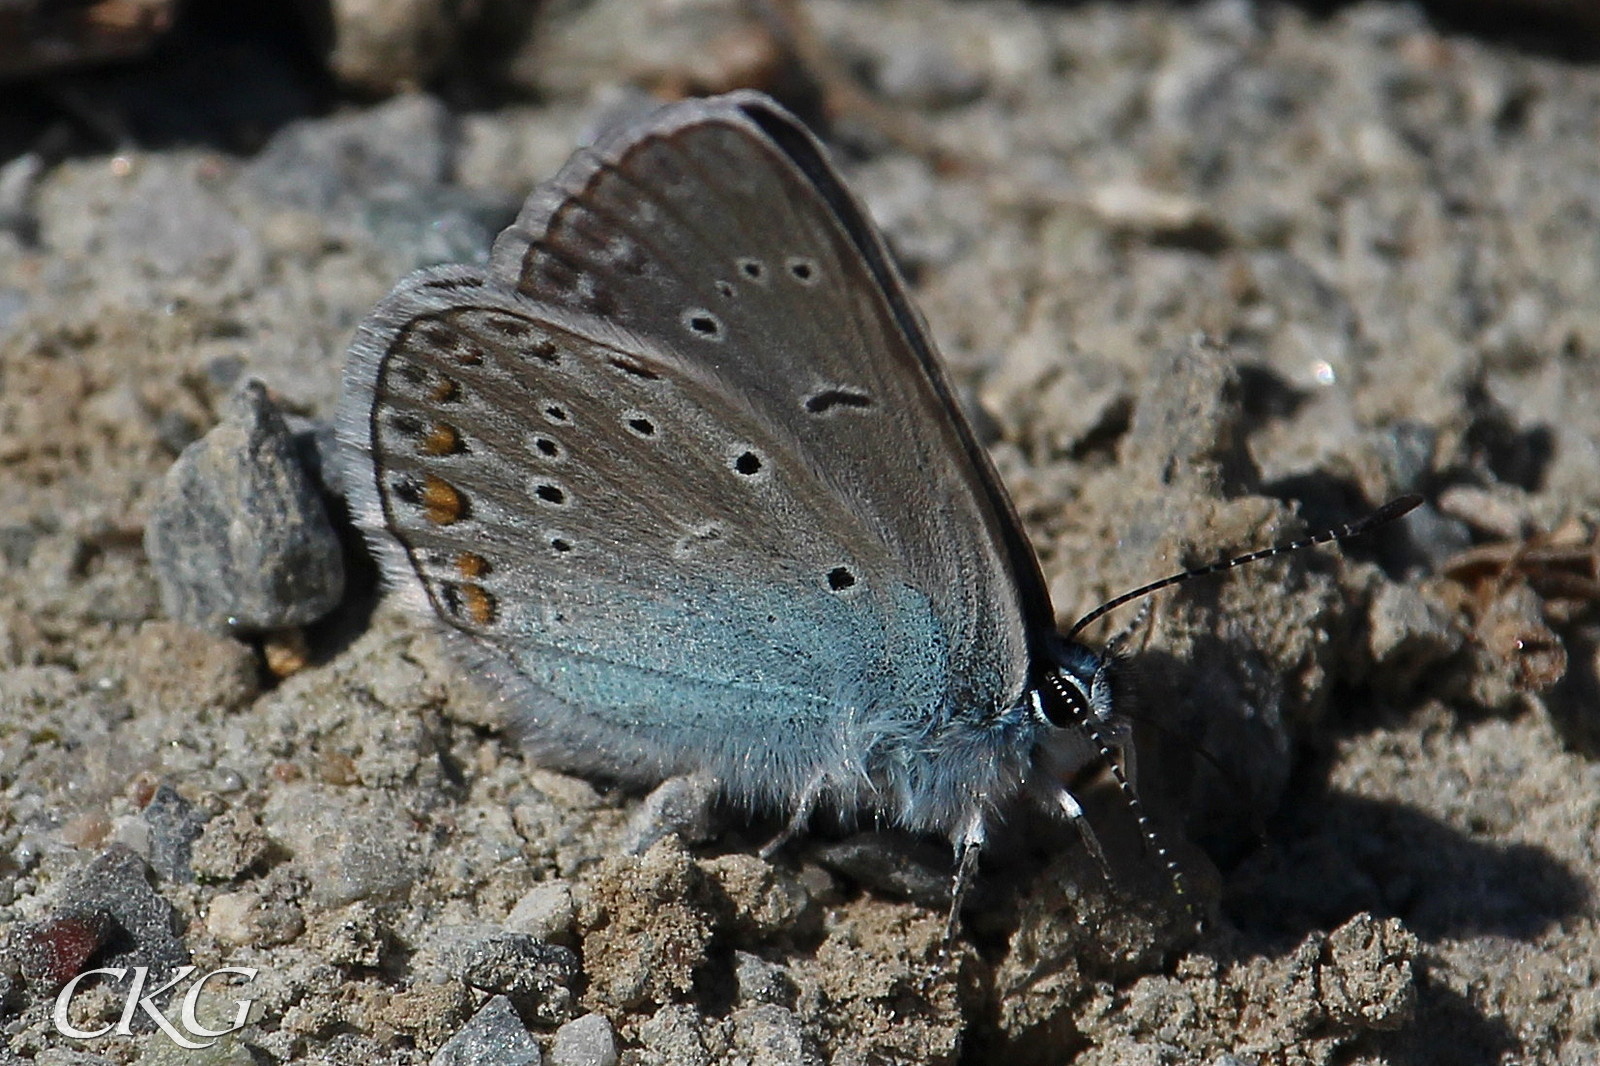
left=0, top=0, right=1600, bottom=1066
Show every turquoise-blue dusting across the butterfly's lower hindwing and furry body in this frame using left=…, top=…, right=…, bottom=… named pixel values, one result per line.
left=514, top=586, right=1035, bottom=836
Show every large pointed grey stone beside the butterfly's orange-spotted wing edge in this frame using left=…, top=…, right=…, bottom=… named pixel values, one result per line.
left=144, top=381, right=344, bottom=632
